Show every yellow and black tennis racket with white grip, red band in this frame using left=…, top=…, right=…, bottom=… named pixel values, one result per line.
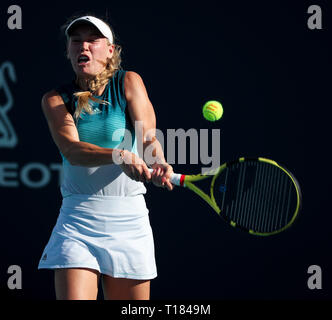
left=151, top=158, right=302, bottom=236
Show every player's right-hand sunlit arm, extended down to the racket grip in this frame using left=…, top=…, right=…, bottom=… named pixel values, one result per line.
left=124, top=71, right=173, bottom=190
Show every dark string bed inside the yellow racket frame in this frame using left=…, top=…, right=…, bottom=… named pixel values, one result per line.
left=221, top=161, right=294, bottom=233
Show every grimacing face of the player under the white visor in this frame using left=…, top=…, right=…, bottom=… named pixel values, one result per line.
left=67, top=25, right=114, bottom=78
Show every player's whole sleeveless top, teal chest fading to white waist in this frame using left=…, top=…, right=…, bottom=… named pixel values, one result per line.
left=56, top=70, right=146, bottom=197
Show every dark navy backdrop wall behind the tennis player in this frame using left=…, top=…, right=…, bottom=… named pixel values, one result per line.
left=0, top=0, right=332, bottom=300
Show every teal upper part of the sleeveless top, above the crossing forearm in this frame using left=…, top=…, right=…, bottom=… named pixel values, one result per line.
left=56, top=70, right=137, bottom=154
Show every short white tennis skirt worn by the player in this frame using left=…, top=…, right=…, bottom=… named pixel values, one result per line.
left=38, top=194, right=157, bottom=280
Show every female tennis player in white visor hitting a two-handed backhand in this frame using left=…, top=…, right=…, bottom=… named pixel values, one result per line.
left=38, top=16, right=173, bottom=300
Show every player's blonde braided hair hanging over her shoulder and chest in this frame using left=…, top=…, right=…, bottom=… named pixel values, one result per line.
left=62, top=14, right=122, bottom=120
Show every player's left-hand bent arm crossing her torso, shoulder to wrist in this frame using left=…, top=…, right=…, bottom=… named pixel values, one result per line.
left=42, top=90, right=124, bottom=167
